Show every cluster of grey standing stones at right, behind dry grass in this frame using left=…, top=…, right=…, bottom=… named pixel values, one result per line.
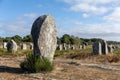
left=93, top=40, right=119, bottom=55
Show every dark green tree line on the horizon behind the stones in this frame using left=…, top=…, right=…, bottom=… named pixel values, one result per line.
left=0, top=34, right=120, bottom=45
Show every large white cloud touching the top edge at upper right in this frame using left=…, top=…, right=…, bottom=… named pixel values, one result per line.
left=61, top=0, right=120, bottom=18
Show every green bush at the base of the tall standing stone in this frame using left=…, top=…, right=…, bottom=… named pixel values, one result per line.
left=20, top=54, right=53, bottom=73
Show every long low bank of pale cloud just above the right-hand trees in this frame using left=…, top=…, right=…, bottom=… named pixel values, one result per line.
left=58, top=20, right=120, bottom=41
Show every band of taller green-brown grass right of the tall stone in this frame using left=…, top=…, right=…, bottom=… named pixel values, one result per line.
left=55, top=46, right=120, bottom=63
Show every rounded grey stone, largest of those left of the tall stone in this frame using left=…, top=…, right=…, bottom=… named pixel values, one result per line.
left=6, top=40, right=17, bottom=52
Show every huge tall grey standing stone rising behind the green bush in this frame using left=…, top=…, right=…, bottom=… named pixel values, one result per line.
left=31, top=15, right=57, bottom=62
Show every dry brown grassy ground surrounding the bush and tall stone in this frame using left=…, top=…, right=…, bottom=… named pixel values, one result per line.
left=0, top=46, right=120, bottom=80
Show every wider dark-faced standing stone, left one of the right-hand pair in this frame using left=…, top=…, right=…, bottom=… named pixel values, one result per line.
left=93, top=42, right=102, bottom=55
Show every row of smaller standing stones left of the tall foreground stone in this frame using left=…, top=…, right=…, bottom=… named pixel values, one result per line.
left=3, top=40, right=33, bottom=52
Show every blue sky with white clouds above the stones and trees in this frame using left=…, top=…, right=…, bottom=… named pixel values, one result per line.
left=0, top=0, right=120, bottom=41
